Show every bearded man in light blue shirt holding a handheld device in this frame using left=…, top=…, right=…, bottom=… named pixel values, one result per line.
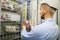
left=21, top=3, right=59, bottom=40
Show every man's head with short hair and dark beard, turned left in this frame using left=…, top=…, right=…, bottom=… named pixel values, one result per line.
left=40, top=3, right=56, bottom=19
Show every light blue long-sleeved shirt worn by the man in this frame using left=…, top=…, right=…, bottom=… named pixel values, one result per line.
left=21, top=18, right=59, bottom=40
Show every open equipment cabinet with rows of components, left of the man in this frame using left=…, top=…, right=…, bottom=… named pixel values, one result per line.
left=0, top=0, right=22, bottom=40
